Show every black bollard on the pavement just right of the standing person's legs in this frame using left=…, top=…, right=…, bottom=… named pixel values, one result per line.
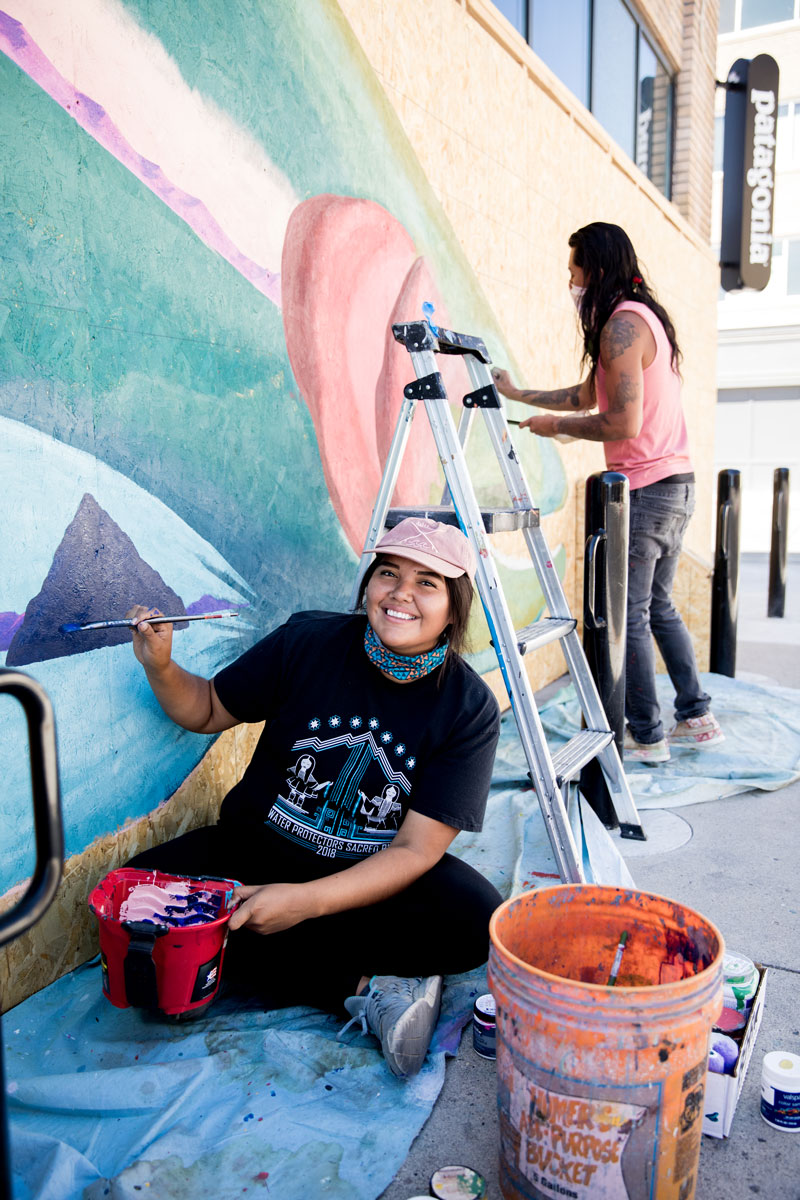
left=709, top=469, right=741, bottom=678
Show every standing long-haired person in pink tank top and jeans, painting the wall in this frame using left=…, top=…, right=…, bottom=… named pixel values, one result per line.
left=492, top=221, right=724, bottom=763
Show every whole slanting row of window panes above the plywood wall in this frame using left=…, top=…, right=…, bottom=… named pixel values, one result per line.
left=494, top=0, right=671, bottom=197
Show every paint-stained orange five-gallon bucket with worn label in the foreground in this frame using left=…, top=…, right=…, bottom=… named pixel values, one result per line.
left=489, top=884, right=724, bottom=1200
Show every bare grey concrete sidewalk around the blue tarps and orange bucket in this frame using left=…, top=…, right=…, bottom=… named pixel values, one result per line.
left=381, top=556, right=800, bottom=1200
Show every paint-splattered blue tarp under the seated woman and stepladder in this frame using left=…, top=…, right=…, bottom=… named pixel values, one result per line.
left=2, top=718, right=631, bottom=1200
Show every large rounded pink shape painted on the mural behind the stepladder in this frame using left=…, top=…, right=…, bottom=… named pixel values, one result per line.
left=281, top=194, right=437, bottom=553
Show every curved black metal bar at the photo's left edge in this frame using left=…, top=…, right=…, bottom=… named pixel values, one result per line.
left=0, top=671, right=64, bottom=1200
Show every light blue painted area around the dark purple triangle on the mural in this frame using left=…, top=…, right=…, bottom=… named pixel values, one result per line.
left=0, top=418, right=255, bottom=892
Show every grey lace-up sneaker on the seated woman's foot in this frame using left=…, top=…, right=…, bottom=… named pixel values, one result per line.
left=339, top=976, right=441, bottom=1078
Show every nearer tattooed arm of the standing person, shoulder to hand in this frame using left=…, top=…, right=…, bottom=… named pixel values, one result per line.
left=521, top=312, right=655, bottom=442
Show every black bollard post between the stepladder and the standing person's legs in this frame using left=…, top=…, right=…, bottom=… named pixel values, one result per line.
left=579, top=470, right=630, bottom=829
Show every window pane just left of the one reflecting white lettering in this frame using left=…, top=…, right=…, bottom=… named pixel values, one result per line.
left=591, top=0, right=637, bottom=158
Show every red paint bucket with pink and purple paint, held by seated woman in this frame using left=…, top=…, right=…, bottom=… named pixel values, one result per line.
left=89, top=866, right=236, bottom=1016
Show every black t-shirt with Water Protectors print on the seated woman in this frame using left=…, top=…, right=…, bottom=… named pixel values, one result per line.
left=215, top=612, right=500, bottom=874
